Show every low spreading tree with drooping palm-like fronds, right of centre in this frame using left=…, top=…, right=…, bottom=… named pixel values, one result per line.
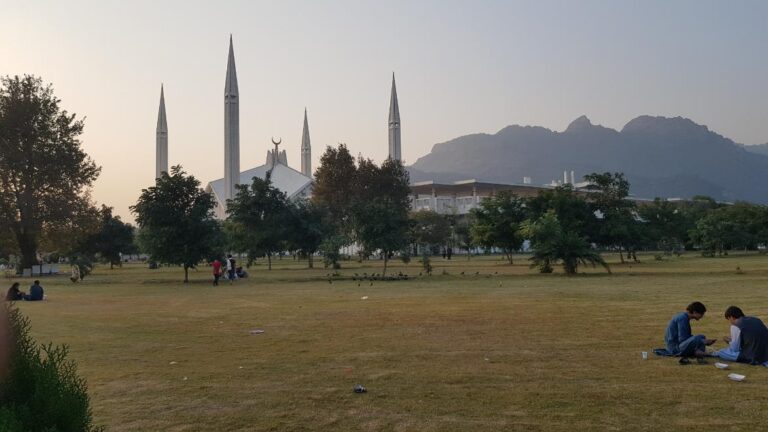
left=522, top=210, right=611, bottom=276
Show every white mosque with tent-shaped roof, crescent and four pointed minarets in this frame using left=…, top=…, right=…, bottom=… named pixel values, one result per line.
left=155, top=36, right=402, bottom=219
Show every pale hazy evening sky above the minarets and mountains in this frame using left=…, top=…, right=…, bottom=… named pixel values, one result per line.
left=0, top=0, right=768, bottom=221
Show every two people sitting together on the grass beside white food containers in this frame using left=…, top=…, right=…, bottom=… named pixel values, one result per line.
left=664, top=302, right=768, bottom=367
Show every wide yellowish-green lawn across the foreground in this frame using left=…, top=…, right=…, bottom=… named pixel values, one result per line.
left=8, top=255, right=768, bottom=431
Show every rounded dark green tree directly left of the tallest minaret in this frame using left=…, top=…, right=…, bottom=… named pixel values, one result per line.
left=131, top=165, right=221, bottom=283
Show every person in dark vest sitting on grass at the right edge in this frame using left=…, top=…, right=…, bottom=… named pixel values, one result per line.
left=712, top=306, right=768, bottom=367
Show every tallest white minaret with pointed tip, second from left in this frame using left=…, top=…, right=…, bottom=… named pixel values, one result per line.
left=222, top=35, right=240, bottom=205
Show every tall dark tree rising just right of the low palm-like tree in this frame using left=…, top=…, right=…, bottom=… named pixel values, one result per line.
left=584, top=172, right=640, bottom=263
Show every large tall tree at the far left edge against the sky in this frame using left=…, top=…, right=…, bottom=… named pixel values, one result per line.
left=0, top=75, right=100, bottom=268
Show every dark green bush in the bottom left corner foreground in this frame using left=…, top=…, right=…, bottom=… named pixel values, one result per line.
left=0, top=307, right=102, bottom=432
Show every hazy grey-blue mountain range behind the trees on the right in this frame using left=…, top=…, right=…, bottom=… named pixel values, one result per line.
left=409, top=116, right=768, bottom=204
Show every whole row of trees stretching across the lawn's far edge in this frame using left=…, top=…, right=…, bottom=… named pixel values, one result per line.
left=0, top=76, right=768, bottom=279
